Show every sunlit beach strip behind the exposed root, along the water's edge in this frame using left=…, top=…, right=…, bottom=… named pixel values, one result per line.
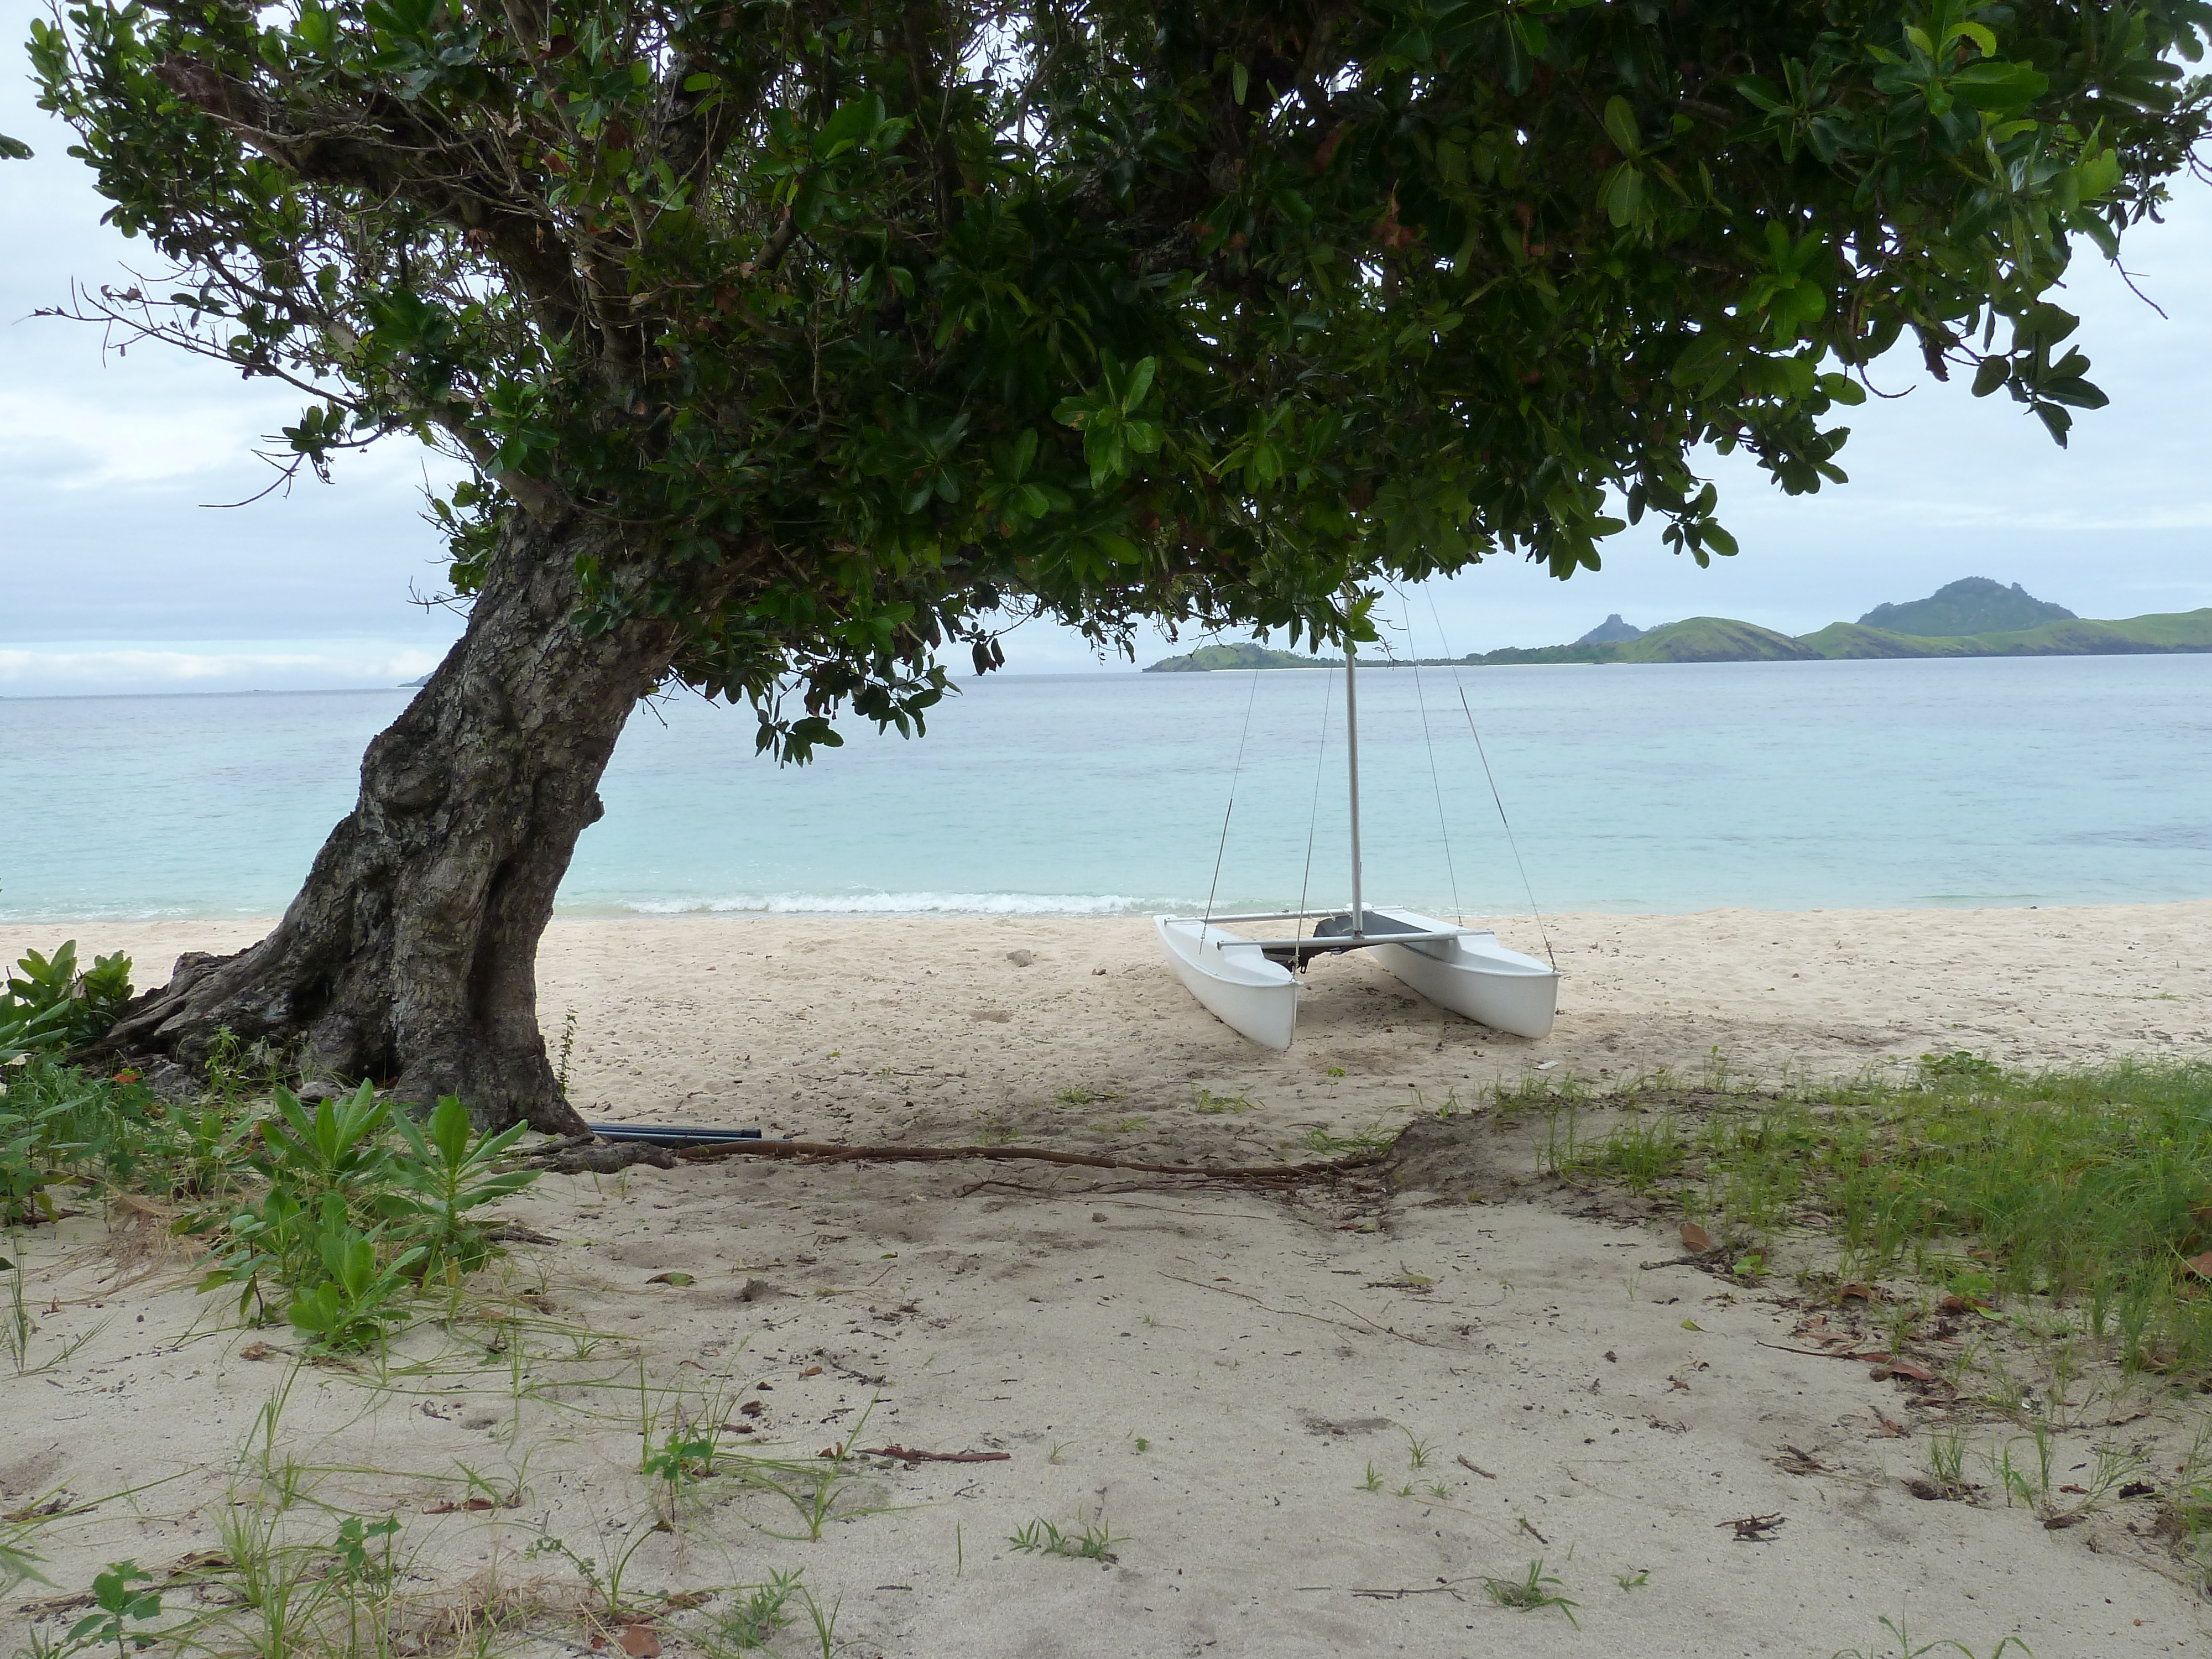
left=22, top=900, right=2212, bottom=1155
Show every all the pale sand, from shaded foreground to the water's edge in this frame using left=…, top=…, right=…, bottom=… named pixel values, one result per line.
left=0, top=902, right=2212, bottom=1659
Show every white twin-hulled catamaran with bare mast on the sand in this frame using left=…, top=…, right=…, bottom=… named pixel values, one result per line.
left=1152, top=646, right=1559, bottom=1048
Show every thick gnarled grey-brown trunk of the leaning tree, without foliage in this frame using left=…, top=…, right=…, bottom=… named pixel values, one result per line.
left=104, top=513, right=677, bottom=1133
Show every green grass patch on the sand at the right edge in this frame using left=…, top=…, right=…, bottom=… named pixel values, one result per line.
left=1559, top=1053, right=2212, bottom=1380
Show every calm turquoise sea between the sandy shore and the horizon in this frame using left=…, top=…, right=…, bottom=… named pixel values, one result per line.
left=0, top=657, right=2212, bottom=920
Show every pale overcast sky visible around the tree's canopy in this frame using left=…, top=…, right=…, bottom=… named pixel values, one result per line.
left=0, top=0, right=2212, bottom=697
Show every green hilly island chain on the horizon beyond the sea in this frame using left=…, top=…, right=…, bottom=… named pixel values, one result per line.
left=1144, top=575, right=2212, bottom=675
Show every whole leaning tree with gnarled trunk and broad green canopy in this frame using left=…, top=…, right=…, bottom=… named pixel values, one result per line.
left=31, top=0, right=2212, bottom=1128
